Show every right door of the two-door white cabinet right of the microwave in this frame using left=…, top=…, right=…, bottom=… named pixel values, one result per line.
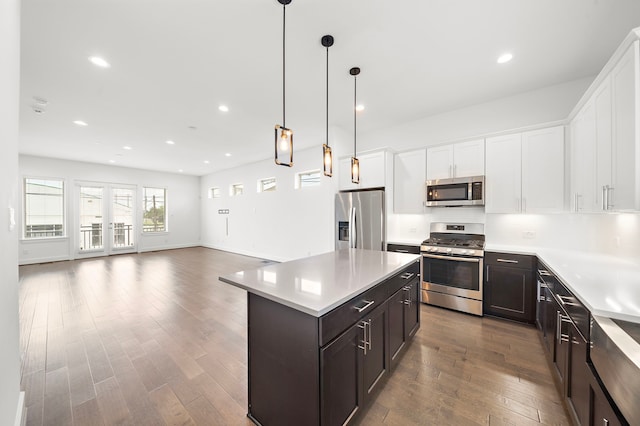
left=521, top=126, right=564, bottom=213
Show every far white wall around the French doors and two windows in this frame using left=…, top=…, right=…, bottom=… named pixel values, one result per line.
left=16, top=155, right=200, bottom=264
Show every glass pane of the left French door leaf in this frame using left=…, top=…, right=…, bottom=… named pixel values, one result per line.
left=80, top=186, right=103, bottom=250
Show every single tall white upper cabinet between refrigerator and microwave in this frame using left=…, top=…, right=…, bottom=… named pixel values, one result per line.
left=393, top=149, right=427, bottom=213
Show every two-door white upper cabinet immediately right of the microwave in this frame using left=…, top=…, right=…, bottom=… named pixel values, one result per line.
left=485, top=126, right=564, bottom=213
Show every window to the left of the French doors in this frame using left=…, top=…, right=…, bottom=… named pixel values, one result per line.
left=24, top=178, right=64, bottom=238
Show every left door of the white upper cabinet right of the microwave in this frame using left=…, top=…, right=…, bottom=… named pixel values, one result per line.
left=485, top=133, right=522, bottom=213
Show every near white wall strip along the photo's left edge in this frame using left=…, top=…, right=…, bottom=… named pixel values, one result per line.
left=0, top=0, right=24, bottom=425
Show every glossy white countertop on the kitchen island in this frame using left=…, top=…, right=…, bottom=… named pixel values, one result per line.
left=220, top=249, right=420, bottom=317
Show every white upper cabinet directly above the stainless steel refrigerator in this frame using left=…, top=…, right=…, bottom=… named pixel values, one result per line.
left=338, top=151, right=386, bottom=191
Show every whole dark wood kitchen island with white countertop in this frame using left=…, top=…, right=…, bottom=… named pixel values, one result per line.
left=220, top=249, right=420, bottom=426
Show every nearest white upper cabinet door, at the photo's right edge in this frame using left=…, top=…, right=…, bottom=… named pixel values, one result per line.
left=608, top=40, right=640, bottom=210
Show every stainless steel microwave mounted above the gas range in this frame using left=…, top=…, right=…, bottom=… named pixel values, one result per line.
left=425, top=176, right=484, bottom=207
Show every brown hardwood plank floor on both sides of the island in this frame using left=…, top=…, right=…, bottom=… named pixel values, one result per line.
left=20, top=248, right=569, bottom=425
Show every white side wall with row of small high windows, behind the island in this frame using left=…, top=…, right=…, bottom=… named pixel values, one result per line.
left=200, top=144, right=338, bottom=261
